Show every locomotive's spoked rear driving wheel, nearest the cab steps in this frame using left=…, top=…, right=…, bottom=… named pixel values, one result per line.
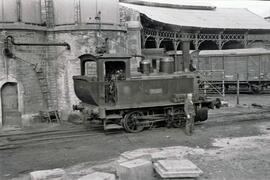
left=123, top=111, right=144, bottom=133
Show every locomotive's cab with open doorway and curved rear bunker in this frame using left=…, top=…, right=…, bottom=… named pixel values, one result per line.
left=73, top=55, right=130, bottom=106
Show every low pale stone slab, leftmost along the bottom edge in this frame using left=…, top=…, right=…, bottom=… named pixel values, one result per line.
left=30, top=168, right=66, bottom=180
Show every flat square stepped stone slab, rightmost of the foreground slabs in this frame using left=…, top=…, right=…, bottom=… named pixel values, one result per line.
left=154, top=159, right=203, bottom=179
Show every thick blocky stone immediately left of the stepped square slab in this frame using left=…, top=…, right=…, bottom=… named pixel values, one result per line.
left=117, top=159, right=154, bottom=180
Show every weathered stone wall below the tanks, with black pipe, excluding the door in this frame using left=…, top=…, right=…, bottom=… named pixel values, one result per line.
left=0, top=24, right=128, bottom=125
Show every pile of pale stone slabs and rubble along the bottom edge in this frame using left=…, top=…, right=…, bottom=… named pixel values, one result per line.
left=30, top=146, right=204, bottom=180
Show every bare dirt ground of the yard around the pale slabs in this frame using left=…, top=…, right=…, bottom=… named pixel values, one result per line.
left=0, top=95, right=270, bottom=180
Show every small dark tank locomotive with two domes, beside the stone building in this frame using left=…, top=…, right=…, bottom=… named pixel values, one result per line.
left=73, top=54, right=214, bottom=133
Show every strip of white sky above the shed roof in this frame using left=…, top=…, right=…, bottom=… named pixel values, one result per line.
left=141, top=0, right=270, bottom=17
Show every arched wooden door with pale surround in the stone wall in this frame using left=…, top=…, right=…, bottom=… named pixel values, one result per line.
left=1, top=82, right=21, bottom=127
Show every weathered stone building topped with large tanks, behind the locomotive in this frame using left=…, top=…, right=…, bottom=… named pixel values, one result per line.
left=0, top=0, right=140, bottom=127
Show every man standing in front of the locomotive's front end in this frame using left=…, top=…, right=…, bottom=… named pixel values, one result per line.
left=184, top=93, right=195, bottom=136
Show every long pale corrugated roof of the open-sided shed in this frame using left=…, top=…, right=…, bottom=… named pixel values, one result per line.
left=120, top=3, right=270, bottom=30
